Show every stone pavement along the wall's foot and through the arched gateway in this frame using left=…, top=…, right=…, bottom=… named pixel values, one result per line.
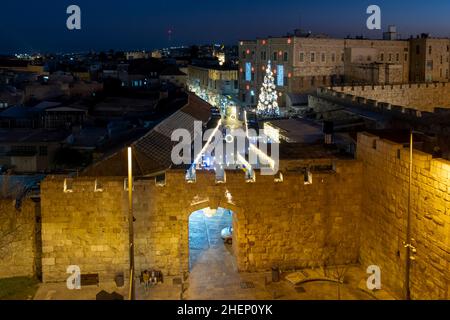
left=35, top=210, right=391, bottom=300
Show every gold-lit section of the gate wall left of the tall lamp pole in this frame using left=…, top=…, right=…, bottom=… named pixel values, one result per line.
left=41, top=177, right=129, bottom=282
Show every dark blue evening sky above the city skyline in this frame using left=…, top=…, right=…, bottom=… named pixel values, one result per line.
left=0, top=0, right=450, bottom=53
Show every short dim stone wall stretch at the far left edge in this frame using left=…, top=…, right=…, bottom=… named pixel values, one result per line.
left=0, top=198, right=40, bottom=278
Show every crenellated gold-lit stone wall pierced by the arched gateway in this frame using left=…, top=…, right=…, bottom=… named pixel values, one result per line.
left=38, top=161, right=362, bottom=281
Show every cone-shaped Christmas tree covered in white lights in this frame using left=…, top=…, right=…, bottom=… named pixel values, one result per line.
left=257, top=60, right=280, bottom=117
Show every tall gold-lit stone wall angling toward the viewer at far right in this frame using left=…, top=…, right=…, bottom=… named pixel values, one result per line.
left=357, top=134, right=450, bottom=299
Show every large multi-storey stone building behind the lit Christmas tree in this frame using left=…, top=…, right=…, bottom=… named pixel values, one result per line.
left=239, top=30, right=450, bottom=106
